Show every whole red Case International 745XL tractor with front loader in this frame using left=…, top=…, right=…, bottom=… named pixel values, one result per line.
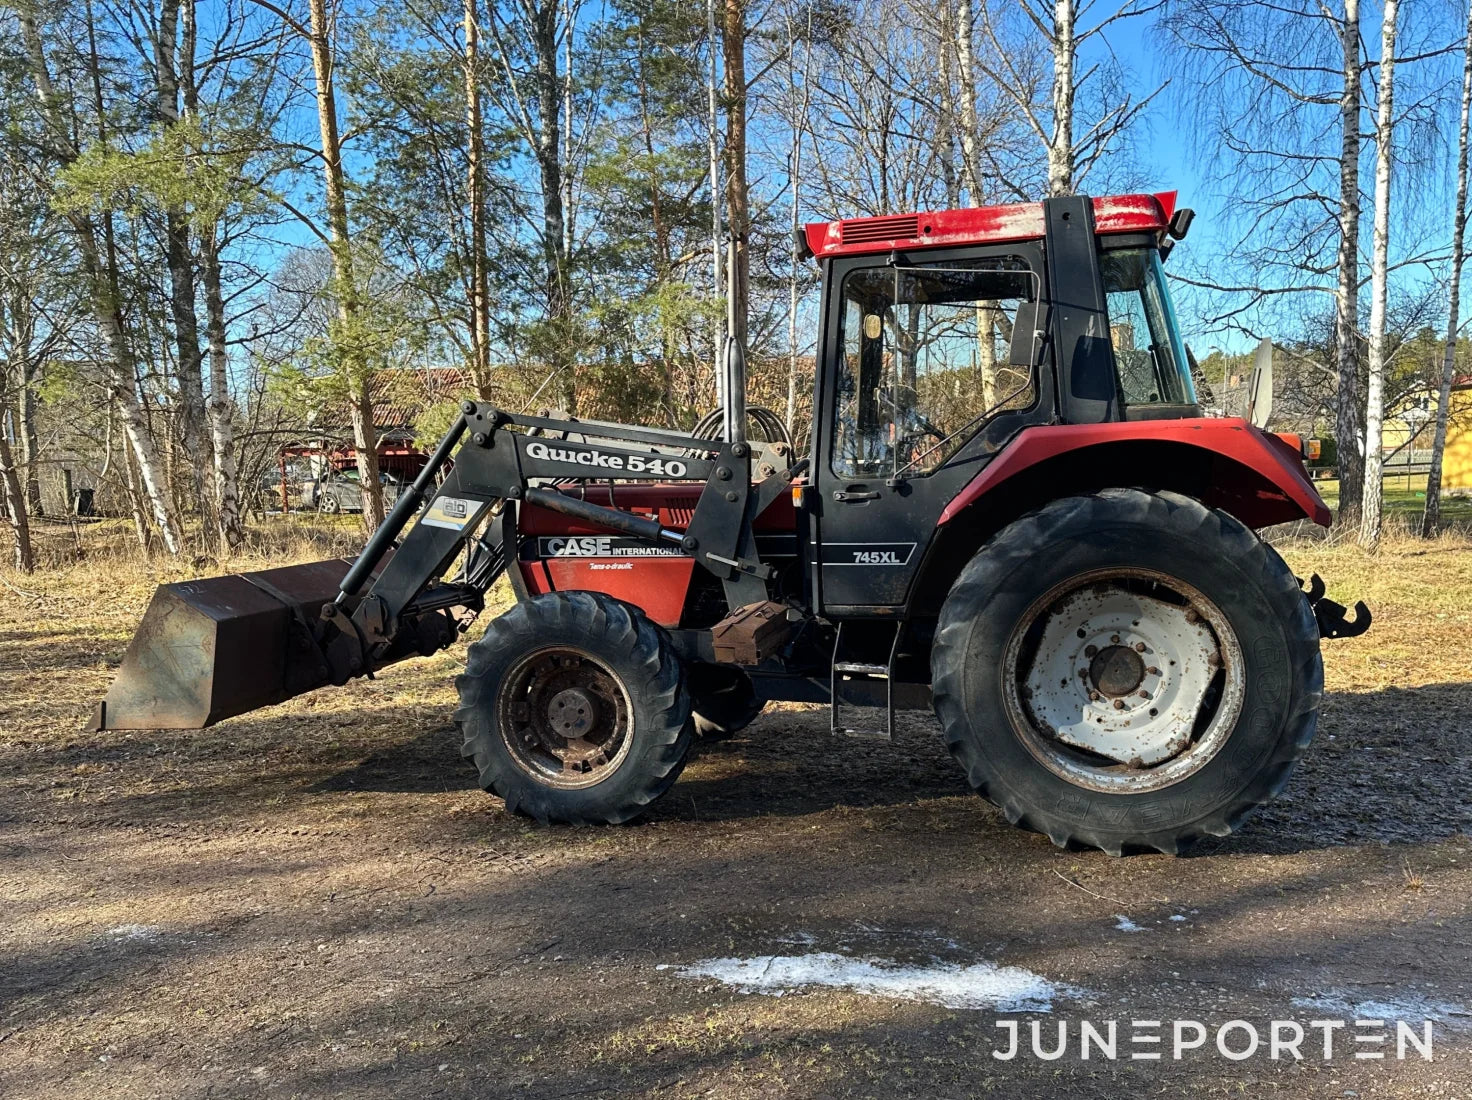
left=94, top=194, right=1369, bottom=854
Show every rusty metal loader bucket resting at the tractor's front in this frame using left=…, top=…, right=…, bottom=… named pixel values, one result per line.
left=88, top=558, right=350, bottom=729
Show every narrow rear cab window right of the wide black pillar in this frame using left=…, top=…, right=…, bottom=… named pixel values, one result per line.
left=1100, top=247, right=1197, bottom=408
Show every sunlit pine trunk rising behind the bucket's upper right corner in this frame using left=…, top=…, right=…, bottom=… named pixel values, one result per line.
left=308, top=0, right=384, bottom=532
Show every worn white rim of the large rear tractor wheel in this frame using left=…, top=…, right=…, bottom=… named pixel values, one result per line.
left=1004, top=570, right=1245, bottom=794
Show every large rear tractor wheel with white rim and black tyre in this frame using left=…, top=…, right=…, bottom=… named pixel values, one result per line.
left=932, top=489, right=1323, bottom=856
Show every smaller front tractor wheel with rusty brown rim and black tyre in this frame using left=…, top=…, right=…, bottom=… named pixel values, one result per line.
left=455, top=592, right=692, bottom=825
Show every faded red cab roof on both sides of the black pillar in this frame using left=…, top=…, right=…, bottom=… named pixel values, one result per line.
left=804, top=191, right=1176, bottom=256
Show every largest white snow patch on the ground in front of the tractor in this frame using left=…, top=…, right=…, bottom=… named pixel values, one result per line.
left=680, top=951, right=1079, bottom=1012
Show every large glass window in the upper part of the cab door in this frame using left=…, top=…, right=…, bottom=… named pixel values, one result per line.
left=832, top=259, right=1036, bottom=479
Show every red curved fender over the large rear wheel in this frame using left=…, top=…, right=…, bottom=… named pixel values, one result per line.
left=938, top=417, right=1332, bottom=529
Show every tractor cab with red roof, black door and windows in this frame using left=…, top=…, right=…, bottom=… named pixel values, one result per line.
left=804, top=193, right=1200, bottom=614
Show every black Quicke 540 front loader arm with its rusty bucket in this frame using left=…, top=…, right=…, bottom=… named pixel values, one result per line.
left=91, top=401, right=793, bottom=729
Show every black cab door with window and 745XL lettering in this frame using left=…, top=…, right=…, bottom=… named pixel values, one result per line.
left=814, top=244, right=1052, bottom=614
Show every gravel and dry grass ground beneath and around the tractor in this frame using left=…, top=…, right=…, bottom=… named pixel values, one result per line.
left=0, top=530, right=1472, bottom=1100
